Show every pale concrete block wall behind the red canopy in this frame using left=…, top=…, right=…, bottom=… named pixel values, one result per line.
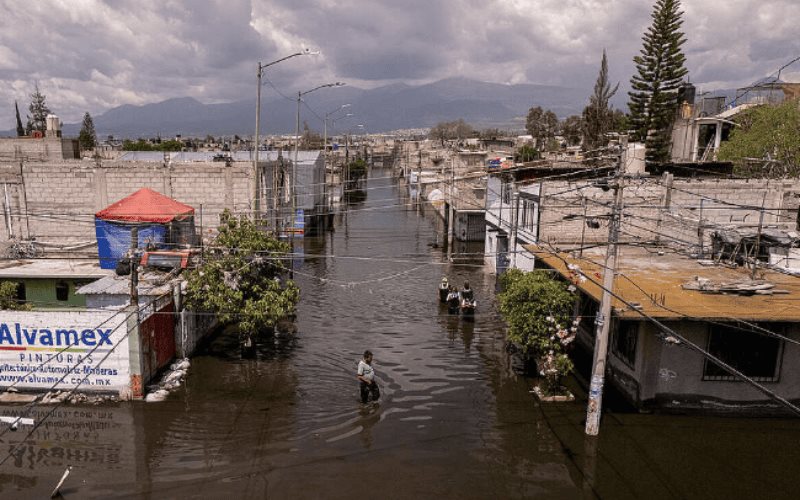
left=0, top=160, right=252, bottom=245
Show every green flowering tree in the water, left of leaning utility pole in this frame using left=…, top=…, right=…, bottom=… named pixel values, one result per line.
left=498, top=269, right=578, bottom=394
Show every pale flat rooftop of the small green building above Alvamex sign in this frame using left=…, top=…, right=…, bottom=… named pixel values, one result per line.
left=0, top=259, right=114, bottom=279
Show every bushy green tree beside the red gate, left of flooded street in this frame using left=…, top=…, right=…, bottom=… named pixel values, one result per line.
left=187, top=210, right=300, bottom=346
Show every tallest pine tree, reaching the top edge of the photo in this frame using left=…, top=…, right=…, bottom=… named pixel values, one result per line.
left=628, top=0, right=687, bottom=162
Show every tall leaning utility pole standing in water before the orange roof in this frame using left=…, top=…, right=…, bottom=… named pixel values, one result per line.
left=586, top=137, right=628, bottom=436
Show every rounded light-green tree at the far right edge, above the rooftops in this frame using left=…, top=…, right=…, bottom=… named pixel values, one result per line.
left=718, top=100, right=800, bottom=178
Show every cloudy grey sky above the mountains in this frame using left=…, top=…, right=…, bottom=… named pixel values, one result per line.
left=0, top=0, right=800, bottom=129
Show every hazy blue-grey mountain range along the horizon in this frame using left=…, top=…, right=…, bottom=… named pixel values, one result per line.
left=45, top=78, right=612, bottom=138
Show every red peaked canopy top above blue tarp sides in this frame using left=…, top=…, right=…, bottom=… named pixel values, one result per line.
left=94, top=188, right=194, bottom=224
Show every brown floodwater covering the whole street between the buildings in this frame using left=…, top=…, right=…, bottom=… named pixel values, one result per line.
left=0, top=170, right=800, bottom=499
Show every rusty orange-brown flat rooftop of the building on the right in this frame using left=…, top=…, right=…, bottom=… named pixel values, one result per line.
left=525, top=245, right=800, bottom=322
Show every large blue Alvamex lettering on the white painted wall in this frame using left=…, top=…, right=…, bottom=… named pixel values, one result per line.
left=0, top=323, right=114, bottom=352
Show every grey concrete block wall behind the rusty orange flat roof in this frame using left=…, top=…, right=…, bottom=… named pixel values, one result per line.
left=539, top=178, right=800, bottom=252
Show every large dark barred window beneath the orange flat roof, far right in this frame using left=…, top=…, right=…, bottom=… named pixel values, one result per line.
left=703, top=323, right=784, bottom=382
